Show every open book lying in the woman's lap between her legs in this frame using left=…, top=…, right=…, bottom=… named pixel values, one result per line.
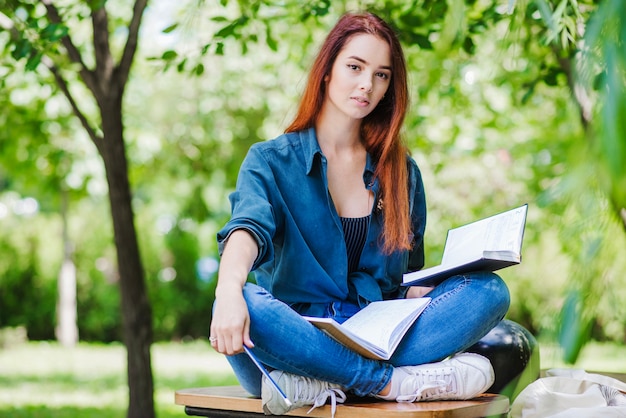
left=304, top=298, right=430, bottom=360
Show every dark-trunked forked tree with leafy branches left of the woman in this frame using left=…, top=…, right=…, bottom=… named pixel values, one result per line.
left=0, top=0, right=154, bottom=417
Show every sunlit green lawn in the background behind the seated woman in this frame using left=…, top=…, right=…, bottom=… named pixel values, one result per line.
left=0, top=341, right=626, bottom=418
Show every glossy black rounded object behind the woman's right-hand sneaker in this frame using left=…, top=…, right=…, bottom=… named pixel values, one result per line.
left=465, top=319, right=540, bottom=402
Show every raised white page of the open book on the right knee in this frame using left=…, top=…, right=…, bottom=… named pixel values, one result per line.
left=442, top=205, right=528, bottom=266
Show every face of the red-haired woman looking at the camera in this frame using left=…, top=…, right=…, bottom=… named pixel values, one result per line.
left=324, top=34, right=391, bottom=119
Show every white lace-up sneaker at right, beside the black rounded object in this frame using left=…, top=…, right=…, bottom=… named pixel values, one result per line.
left=396, top=353, right=495, bottom=402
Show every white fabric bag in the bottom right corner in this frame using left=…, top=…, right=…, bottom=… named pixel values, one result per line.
left=509, top=369, right=626, bottom=418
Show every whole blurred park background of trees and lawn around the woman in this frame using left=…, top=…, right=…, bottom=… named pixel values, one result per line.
left=0, top=0, right=626, bottom=417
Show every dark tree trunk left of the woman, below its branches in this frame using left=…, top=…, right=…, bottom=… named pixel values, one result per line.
left=101, top=95, right=155, bottom=418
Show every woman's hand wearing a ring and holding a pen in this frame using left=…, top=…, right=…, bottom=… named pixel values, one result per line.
left=209, top=286, right=253, bottom=355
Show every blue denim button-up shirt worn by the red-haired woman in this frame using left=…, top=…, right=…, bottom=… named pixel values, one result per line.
left=217, top=128, right=426, bottom=316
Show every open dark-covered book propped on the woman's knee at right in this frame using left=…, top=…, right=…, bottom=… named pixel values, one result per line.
left=402, top=205, right=528, bottom=286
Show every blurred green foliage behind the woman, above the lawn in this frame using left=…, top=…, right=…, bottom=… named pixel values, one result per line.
left=0, top=1, right=626, bottom=354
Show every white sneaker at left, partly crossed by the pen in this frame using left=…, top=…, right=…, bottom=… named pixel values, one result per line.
left=261, top=370, right=346, bottom=417
